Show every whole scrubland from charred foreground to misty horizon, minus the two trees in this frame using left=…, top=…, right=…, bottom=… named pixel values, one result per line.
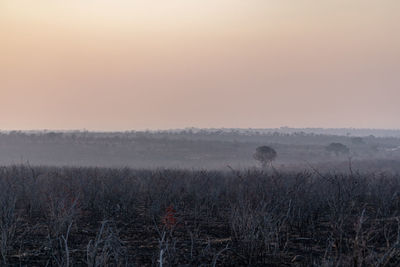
left=0, top=129, right=400, bottom=266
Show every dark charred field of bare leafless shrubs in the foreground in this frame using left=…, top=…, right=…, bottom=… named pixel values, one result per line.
left=0, top=165, right=400, bottom=266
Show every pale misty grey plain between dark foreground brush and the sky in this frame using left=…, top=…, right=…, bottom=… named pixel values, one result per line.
left=0, top=129, right=400, bottom=172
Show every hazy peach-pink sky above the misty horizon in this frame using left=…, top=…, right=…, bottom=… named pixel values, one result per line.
left=0, top=0, right=400, bottom=130
